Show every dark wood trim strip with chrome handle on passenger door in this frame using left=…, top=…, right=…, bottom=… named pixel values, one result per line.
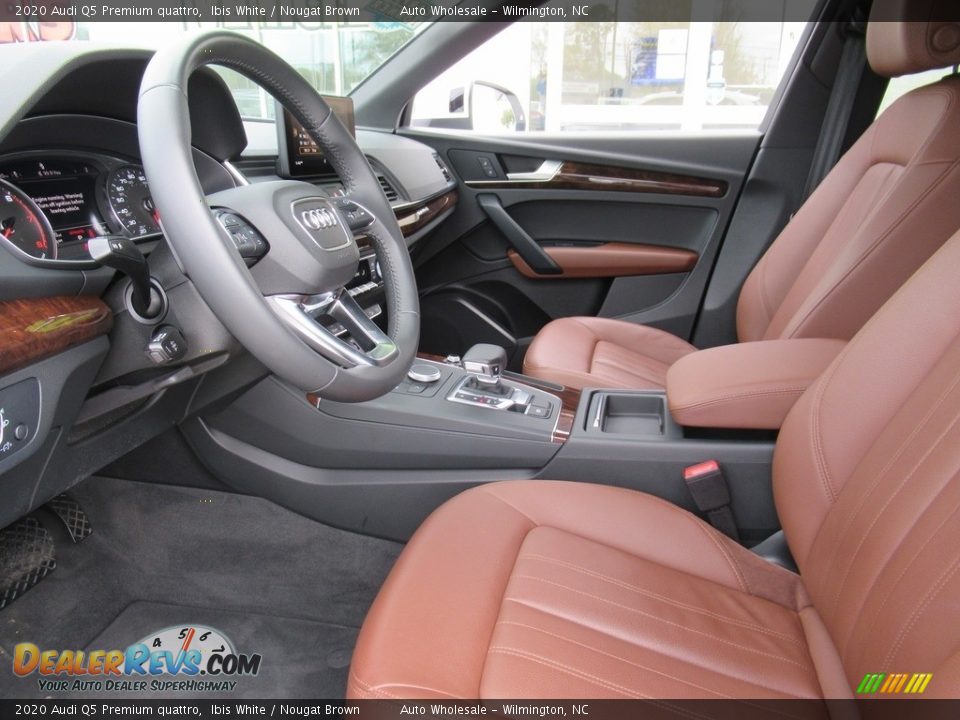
left=467, top=161, right=728, bottom=198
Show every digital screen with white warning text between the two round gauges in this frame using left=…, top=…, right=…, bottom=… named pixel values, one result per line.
left=20, top=176, right=104, bottom=245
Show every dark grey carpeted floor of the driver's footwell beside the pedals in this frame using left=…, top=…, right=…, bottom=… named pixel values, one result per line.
left=0, top=478, right=400, bottom=698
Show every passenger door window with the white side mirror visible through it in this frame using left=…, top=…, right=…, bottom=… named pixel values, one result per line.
left=411, top=16, right=807, bottom=134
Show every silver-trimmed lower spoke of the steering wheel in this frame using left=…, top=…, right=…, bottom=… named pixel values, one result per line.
left=267, top=288, right=400, bottom=368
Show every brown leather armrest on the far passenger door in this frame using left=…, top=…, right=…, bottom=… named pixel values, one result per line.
left=507, top=243, right=700, bottom=280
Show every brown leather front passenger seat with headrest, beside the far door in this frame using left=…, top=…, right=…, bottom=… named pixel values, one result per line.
left=524, top=0, right=960, bottom=388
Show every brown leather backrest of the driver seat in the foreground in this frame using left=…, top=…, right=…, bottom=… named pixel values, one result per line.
left=774, top=225, right=960, bottom=697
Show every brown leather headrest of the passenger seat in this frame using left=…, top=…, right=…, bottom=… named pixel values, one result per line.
left=867, top=0, right=960, bottom=77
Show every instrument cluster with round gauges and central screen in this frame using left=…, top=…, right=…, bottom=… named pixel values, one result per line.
left=0, top=152, right=160, bottom=262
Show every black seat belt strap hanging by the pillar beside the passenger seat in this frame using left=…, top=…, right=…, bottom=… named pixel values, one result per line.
left=801, top=12, right=867, bottom=205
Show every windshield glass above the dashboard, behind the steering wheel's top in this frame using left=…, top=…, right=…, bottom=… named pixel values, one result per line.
left=0, top=21, right=428, bottom=120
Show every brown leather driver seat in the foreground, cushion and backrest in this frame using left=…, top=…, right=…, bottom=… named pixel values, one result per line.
left=348, top=225, right=960, bottom=699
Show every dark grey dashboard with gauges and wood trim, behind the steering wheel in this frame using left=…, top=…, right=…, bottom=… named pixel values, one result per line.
left=0, top=43, right=458, bottom=526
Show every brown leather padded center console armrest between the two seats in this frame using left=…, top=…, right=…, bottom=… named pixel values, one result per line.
left=667, top=338, right=846, bottom=430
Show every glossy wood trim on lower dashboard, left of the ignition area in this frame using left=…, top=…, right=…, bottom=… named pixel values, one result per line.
left=0, top=295, right=113, bottom=375
